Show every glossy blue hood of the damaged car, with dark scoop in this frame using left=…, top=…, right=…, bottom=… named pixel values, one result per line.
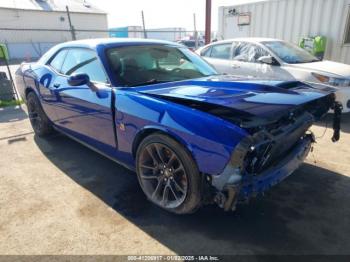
left=138, top=76, right=331, bottom=124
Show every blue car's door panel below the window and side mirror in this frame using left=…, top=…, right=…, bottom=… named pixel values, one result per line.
left=54, top=85, right=116, bottom=156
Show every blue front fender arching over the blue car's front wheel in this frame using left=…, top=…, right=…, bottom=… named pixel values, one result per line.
left=116, top=90, right=247, bottom=175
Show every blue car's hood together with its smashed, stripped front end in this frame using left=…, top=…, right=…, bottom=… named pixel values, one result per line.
left=139, top=77, right=342, bottom=210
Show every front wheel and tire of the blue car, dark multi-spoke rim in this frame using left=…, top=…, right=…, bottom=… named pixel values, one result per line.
left=136, top=133, right=202, bottom=214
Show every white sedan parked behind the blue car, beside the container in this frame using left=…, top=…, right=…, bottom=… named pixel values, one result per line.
left=196, top=38, right=350, bottom=112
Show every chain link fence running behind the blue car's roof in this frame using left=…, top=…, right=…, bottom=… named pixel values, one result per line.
left=0, top=28, right=204, bottom=63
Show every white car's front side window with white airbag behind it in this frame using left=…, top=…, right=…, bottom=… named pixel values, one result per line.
left=232, top=42, right=269, bottom=63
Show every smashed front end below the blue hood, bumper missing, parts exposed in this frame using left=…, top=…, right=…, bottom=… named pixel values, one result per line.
left=210, top=95, right=342, bottom=211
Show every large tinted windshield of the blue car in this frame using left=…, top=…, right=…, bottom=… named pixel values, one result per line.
left=107, top=45, right=217, bottom=87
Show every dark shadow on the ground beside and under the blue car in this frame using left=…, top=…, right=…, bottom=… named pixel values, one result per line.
left=35, top=135, right=350, bottom=255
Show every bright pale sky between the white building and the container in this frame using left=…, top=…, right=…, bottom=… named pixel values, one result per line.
left=88, top=0, right=262, bottom=31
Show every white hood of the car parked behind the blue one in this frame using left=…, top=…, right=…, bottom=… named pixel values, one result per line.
left=289, top=61, right=350, bottom=78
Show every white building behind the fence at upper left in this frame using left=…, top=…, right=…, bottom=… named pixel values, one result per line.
left=0, top=0, right=108, bottom=59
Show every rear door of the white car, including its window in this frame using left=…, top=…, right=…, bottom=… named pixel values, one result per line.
left=201, top=42, right=232, bottom=74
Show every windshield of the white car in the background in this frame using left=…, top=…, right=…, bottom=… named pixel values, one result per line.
left=262, top=41, right=319, bottom=64
